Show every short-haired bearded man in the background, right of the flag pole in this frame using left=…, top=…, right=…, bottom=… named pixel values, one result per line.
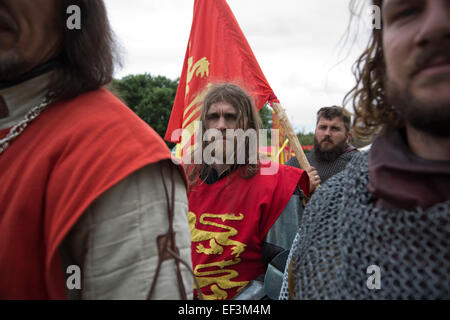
left=286, top=106, right=359, bottom=189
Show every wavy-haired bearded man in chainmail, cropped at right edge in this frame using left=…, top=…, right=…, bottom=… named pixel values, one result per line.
left=280, top=0, right=450, bottom=299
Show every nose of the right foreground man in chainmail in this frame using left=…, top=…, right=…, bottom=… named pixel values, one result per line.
left=416, top=0, right=450, bottom=46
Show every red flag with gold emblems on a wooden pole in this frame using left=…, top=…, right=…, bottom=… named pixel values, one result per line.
left=165, top=0, right=278, bottom=143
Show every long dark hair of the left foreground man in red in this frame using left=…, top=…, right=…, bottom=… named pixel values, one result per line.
left=47, top=0, right=120, bottom=100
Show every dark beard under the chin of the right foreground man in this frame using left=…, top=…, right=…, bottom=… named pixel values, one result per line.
left=386, top=80, right=450, bottom=137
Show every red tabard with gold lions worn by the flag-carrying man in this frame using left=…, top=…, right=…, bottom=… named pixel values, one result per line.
left=189, top=163, right=309, bottom=299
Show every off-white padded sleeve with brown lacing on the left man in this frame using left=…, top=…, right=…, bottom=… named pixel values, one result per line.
left=60, top=160, right=193, bottom=299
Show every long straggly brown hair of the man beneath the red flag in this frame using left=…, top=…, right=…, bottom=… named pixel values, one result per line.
left=187, top=83, right=262, bottom=187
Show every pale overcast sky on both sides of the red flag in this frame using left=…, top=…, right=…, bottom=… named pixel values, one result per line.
left=105, top=0, right=370, bottom=132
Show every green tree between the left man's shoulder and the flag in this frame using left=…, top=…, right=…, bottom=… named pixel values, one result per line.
left=111, top=73, right=179, bottom=148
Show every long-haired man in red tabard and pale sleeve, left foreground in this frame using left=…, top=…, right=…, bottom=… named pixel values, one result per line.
left=0, top=0, right=193, bottom=300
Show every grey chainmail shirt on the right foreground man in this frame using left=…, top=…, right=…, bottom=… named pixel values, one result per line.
left=280, top=152, right=450, bottom=300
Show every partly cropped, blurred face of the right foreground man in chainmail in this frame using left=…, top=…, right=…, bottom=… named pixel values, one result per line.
left=382, top=0, right=450, bottom=137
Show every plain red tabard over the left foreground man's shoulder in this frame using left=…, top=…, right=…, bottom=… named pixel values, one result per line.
left=0, top=89, right=175, bottom=299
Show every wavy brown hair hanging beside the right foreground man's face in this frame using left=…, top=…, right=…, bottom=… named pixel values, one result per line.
left=344, top=0, right=403, bottom=140
